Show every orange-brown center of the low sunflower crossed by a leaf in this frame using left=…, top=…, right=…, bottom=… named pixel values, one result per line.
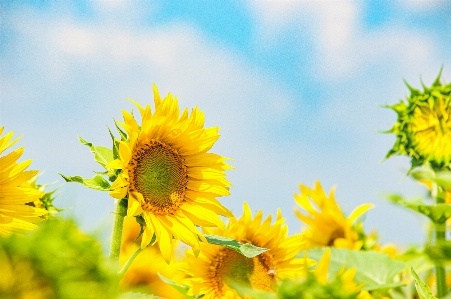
left=208, top=248, right=276, bottom=298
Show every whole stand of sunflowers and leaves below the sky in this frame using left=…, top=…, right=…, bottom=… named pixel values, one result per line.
left=0, top=71, right=451, bottom=299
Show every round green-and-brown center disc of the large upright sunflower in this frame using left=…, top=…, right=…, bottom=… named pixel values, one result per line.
left=129, top=139, right=188, bottom=214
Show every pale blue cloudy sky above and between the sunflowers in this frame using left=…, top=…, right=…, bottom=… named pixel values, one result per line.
left=0, top=1, right=451, bottom=244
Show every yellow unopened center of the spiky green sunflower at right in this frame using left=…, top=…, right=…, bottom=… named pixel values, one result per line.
left=412, top=98, right=451, bottom=161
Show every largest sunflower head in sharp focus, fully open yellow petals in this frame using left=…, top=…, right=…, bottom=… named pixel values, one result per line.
left=105, top=85, right=232, bottom=263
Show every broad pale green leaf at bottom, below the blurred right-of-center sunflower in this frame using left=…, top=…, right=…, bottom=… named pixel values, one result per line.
left=307, top=248, right=405, bottom=291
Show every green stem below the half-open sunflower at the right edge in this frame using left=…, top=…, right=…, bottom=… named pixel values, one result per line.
left=431, top=183, right=446, bottom=298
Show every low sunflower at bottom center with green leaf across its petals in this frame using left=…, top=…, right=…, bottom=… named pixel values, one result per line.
left=179, top=203, right=308, bottom=299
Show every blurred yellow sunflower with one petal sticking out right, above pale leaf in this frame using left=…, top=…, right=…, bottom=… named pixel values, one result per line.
left=294, top=181, right=373, bottom=250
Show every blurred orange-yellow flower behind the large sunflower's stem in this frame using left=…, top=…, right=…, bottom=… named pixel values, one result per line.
left=120, top=217, right=185, bottom=299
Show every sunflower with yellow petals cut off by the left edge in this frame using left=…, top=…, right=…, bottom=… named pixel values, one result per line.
left=0, top=127, right=47, bottom=236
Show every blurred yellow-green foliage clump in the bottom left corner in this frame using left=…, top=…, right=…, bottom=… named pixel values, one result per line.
left=0, top=219, right=117, bottom=299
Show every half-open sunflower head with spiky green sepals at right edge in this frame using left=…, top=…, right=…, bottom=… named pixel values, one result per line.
left=387, top=70, right=451, bottom=170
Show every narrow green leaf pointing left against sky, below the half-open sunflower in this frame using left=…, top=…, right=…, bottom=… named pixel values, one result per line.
left=387, top=194, right=451, bottom=224
